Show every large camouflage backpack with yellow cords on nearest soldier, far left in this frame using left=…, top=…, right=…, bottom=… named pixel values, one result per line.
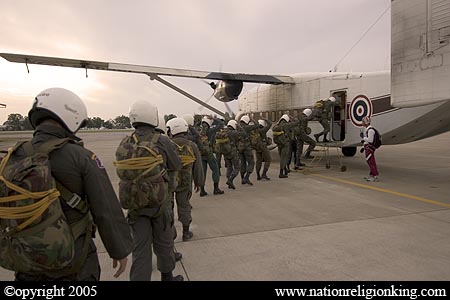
left=0, top=139, right=92, bottom=277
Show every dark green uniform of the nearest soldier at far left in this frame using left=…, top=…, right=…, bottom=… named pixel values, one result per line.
left=15, top=124, right=133, bottom=281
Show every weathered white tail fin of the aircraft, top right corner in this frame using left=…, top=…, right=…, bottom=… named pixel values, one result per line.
left=391, top=0, right=450, bottom=107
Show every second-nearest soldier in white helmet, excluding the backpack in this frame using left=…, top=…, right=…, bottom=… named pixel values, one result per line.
left=119, top=101, right=183, bottom=281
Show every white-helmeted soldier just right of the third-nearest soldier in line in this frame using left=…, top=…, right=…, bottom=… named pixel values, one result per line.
left=200, top=117, right=224, bottom=197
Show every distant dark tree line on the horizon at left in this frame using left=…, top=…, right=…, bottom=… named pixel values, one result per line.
left=1, top=113, right=131, bottom=131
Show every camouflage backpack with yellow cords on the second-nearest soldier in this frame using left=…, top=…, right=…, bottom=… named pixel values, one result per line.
left=114, top=132, right=169, bottom=211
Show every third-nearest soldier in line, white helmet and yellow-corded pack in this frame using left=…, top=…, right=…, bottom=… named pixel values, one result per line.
left=166, top=118, right=205, bottom=241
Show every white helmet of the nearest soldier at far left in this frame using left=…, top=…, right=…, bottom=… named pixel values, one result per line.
left=28, top=88, right=87, bottom=133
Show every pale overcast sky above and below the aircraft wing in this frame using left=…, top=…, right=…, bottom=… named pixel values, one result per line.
left=0, top=0, right=391, bottom=123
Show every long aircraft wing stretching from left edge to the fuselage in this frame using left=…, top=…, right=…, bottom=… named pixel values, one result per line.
left=0, top=53, right=294, bottom=84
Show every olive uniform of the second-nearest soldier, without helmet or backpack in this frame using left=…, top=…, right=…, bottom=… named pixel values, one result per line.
left=124, top=125, right=182, bottom=281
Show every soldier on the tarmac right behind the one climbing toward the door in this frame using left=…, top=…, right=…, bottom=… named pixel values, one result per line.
left=272, top=114, right=298, bottom=178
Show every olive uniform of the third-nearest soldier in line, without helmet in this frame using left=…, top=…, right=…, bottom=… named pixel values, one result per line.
left=172, top=134, right=205, bottom=236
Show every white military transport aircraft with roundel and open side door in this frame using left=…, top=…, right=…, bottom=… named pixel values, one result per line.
left=0, top=0, right=450, bottom=156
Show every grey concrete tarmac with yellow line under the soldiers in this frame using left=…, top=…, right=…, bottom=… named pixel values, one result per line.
left=0, top=131, right=450, bottom=281
